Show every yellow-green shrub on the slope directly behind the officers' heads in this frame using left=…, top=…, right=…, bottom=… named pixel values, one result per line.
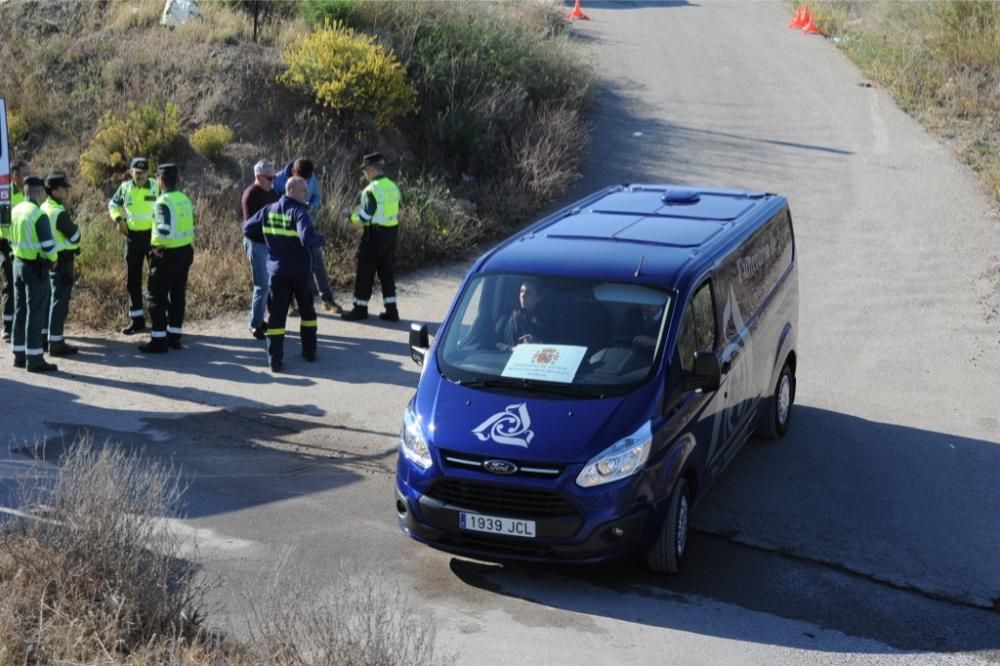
left=80, top=102, right=181, bottom=187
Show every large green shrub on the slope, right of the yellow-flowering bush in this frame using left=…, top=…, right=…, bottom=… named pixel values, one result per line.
left=357, top=2, right=591, bottom=177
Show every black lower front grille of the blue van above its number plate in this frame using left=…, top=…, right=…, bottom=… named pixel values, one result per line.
left=427, top=479, right=577, bottom=517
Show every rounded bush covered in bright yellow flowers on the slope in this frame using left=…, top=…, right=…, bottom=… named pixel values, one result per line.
left=278, top=23, right=416, bottom=127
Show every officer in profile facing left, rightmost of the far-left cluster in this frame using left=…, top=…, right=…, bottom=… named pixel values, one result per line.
left=42, top=172, right=80, bottom=356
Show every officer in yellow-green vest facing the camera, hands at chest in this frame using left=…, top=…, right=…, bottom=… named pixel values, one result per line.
left=108, top=157, right=160, bottom=335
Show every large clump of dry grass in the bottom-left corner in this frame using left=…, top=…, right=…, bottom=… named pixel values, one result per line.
left=0, top=439, right=205, bottom=664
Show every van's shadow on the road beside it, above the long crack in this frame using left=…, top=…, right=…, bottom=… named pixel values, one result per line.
left=694, top=405, right=1000, bottom=608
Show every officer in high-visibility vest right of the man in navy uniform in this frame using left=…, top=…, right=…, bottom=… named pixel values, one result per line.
left=340, top=153, right=400, bottom=321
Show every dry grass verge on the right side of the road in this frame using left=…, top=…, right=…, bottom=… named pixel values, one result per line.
left=810, top=0, right=1000, bottom=201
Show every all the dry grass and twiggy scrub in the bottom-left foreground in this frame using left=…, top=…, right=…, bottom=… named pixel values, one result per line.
left=0, top=438, right=442, bottom=666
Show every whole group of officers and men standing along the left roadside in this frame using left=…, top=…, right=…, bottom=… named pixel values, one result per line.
left=0, top=148, right=400, bottom=372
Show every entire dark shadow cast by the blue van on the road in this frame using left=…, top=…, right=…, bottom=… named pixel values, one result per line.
left=426, top=406, right=1000, bottom=656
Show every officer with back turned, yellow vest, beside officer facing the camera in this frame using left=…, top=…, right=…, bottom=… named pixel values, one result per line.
left=139, top=164, right=194, bottom=354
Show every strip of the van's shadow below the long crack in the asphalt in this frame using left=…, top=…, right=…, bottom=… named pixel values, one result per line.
left=450, top=533, right=1000, bottom=653
